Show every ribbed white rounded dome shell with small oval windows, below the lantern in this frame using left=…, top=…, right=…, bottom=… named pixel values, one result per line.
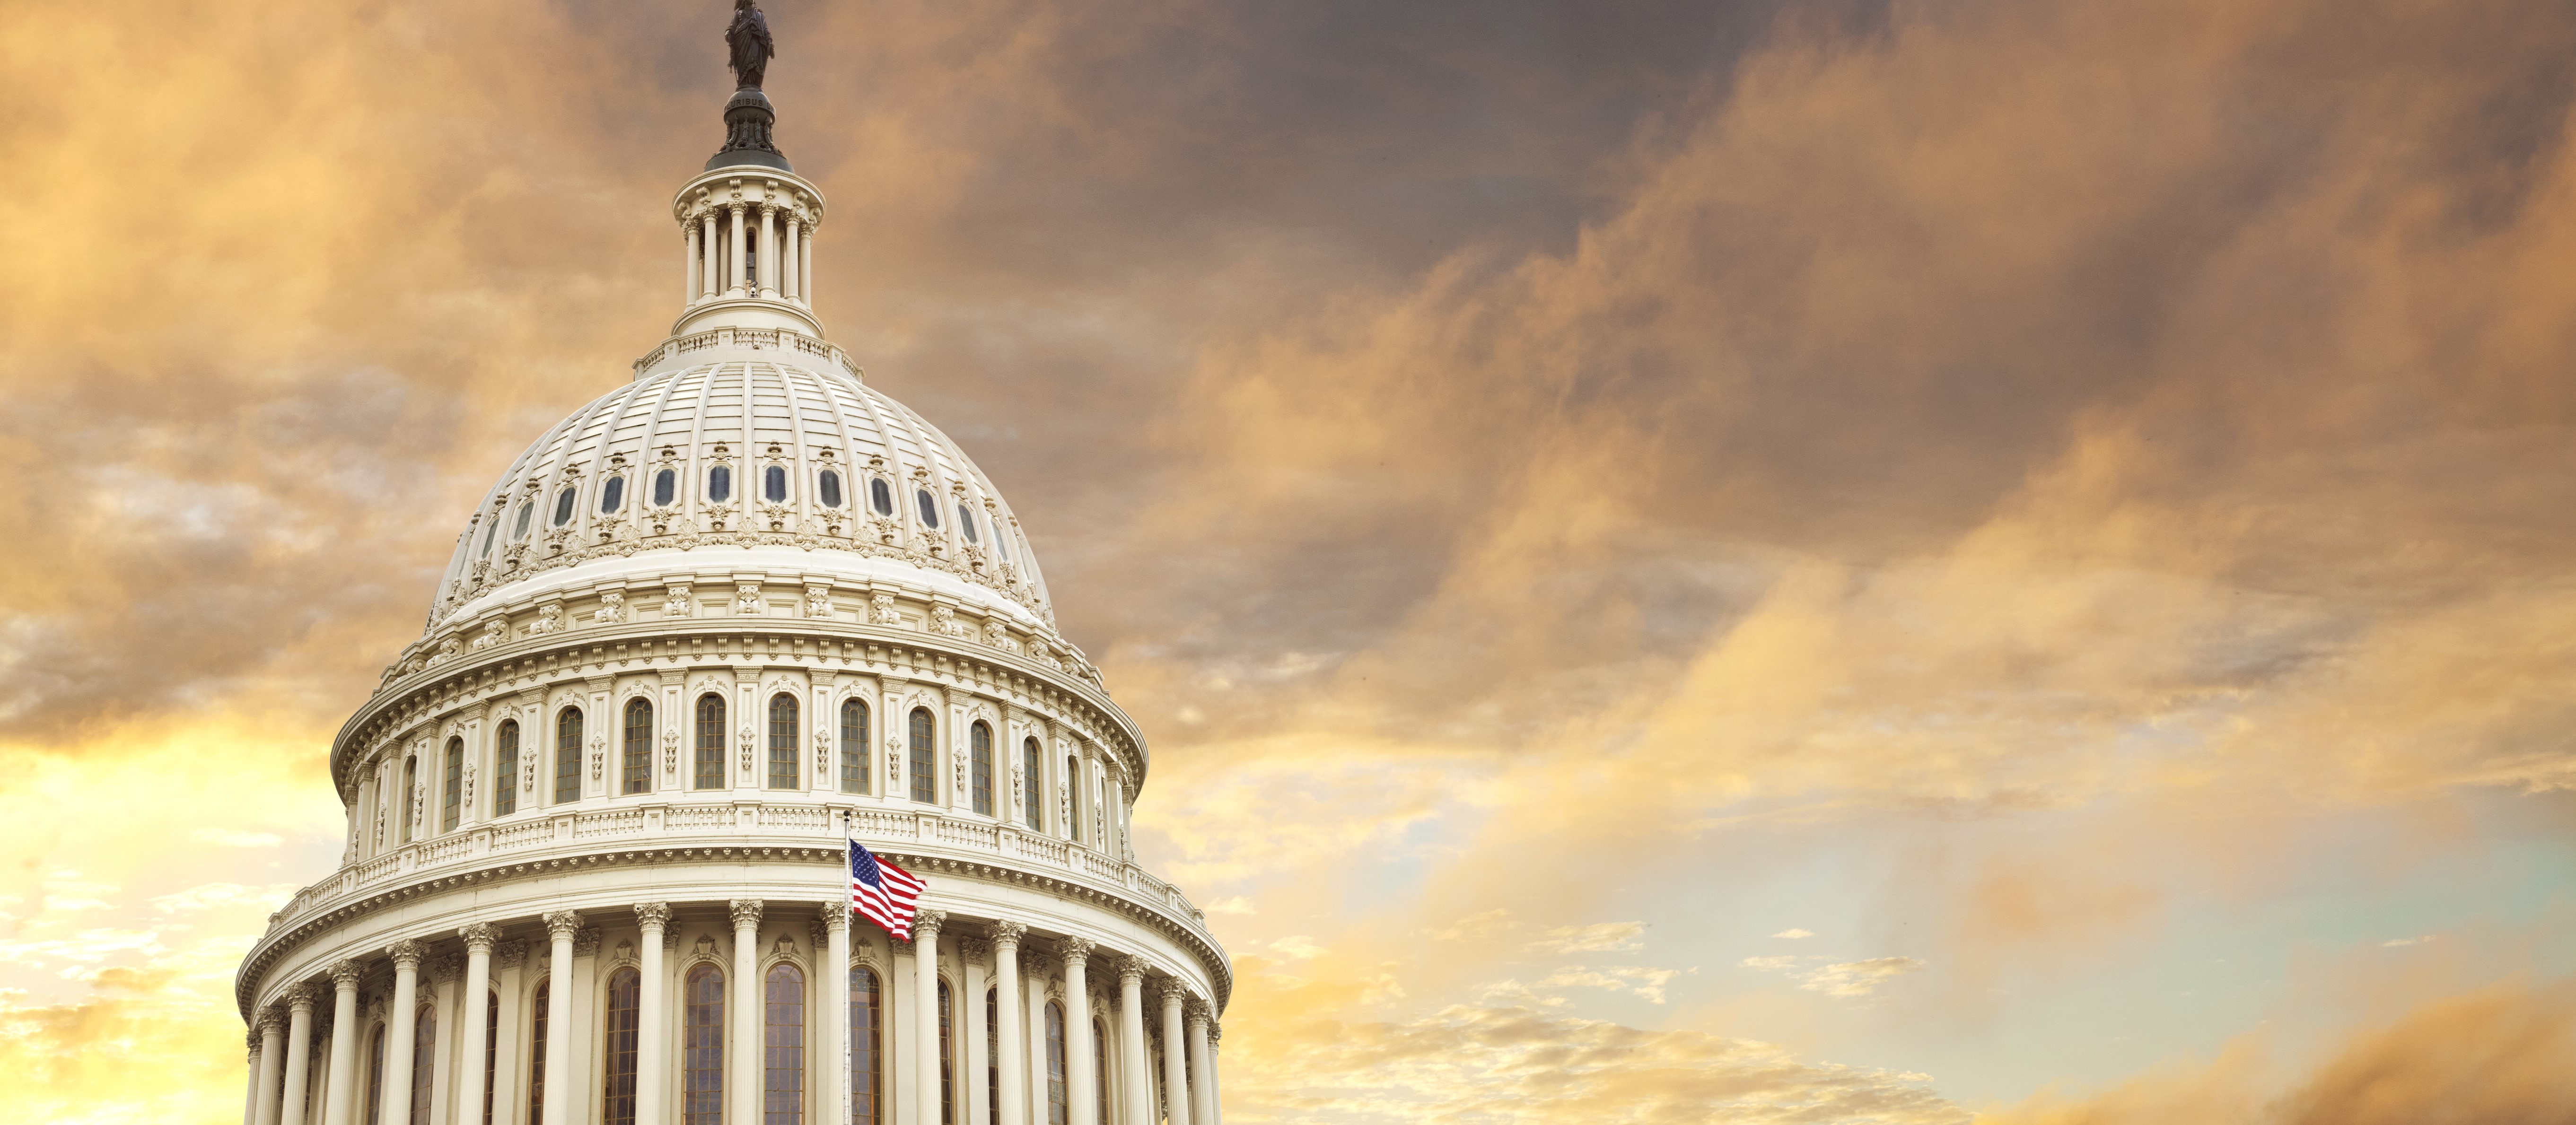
left=428, top=360, right=1053, bottom=636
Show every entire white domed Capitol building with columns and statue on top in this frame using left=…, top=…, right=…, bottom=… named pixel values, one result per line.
left=235, top=19, right=1234, bottom=1125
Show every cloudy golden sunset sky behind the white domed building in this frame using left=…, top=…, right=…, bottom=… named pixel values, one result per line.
left=0, top=0, right=2576, bottom=1125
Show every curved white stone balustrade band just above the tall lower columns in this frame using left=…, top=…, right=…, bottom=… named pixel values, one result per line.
left=268, top=801, right=1213, bottom=942
